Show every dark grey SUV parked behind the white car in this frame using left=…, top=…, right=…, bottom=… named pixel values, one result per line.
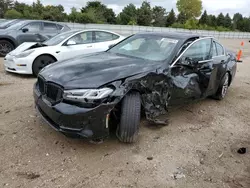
left=0, top=20, right=70, bottom=56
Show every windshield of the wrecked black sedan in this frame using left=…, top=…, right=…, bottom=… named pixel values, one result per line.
left=108, top=35, right=178, bottom=61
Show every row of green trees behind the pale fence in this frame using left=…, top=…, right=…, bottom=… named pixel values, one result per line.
left=0, top=0, right=250, bottom=32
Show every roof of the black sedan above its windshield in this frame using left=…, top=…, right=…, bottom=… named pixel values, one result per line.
left=138, top=32, right=202, bottom=40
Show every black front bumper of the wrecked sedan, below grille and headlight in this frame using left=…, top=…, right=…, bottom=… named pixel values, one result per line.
left=33, top=88, right=114, bottom=139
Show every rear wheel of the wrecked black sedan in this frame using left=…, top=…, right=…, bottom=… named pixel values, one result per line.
left=213, top=72, right=230, bottom=100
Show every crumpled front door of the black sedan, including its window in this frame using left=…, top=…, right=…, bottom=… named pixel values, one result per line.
left=170, top=38, right=217, bottom=105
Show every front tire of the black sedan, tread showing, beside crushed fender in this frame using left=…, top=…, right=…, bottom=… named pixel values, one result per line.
left=117, top=93, right=141, bottom=143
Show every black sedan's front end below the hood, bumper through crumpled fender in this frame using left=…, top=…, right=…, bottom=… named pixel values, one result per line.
left=34, top=67, right=174, bottom=139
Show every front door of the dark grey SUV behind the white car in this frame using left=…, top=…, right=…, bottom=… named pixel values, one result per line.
left=17, top=22, right=46, bottom=45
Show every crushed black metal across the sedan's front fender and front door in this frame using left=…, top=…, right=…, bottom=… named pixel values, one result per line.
left=106, top=64, right=208, bottom=125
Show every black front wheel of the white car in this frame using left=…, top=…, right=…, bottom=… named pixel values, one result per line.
left=32, top=55, right=56, bottom=77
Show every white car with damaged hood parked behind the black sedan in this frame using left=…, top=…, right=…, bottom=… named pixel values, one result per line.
left=4, top=30, right=125, bottom=76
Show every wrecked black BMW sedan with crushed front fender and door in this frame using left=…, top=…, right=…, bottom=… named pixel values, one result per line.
left=34, top=33, right=237, bottom=143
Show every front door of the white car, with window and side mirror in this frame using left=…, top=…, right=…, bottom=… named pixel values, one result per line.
left=58, top=31, right=95, bottom=60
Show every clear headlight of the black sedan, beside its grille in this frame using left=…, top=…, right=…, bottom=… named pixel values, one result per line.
left=63, top=88, right=114, bottom=101
